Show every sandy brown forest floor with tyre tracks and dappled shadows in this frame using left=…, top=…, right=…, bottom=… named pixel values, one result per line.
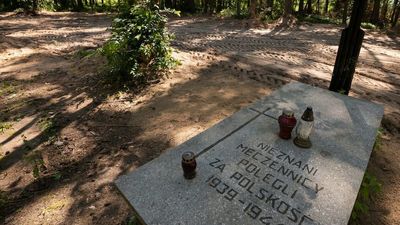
left=0, top=13, right=400, bottom=225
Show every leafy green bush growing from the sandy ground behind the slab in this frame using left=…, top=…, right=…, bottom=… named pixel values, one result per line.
left=100, top=4, right=178, bottom=84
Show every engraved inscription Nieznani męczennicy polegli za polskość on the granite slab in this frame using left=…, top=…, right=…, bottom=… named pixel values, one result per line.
left=206, top=143, right=324, bottom=225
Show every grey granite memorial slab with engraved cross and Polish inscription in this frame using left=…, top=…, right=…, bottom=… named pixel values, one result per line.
left=115, top=82, right=383, bottom=225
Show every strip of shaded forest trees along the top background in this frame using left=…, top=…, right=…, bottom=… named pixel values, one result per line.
left=0, top=0, right=400, bottom=28
